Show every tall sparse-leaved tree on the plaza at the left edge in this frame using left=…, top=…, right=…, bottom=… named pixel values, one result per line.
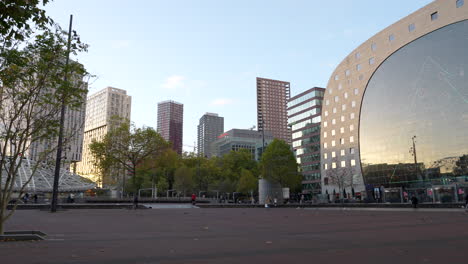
left=0, top=26, right=88, bottom=234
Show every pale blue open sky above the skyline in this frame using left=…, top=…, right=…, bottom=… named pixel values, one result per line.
left=45, top=0, right=432, bottom=151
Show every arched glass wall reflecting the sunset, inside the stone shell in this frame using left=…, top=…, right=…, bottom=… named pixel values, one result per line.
left=359, top=20, right=468, bottom=192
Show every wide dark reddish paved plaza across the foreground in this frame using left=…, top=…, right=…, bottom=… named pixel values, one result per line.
left=0, top=208, right=468, bottom=264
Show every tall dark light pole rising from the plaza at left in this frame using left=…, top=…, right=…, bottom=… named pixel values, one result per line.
left=50, top=15, right=73, bottom=213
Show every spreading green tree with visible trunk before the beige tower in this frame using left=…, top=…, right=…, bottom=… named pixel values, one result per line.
left=89, top=122, right=169, bottom=202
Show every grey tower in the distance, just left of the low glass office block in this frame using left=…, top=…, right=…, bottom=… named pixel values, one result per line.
left=197, top=113, right=224, bottom=157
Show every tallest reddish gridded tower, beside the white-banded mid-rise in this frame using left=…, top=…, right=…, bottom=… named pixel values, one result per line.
left=257, top=77, right=291, bottom=144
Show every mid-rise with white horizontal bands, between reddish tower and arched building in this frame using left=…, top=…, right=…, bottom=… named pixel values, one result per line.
left=287, top=87, right=325, bottom=195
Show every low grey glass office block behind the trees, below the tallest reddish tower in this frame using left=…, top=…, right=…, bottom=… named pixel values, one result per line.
left=211, top=129, right=273, bottom=160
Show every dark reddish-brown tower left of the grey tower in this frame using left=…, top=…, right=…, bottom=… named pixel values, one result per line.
left=158, top=100, right=184, bottom=154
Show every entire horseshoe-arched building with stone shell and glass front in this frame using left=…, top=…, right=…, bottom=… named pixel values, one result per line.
left=321, top=0, right=468, bottom=202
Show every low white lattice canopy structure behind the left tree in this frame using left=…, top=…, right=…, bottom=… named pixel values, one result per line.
left=2, top=158, right=96, bottom=193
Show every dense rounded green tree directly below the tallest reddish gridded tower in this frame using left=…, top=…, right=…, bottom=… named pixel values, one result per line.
left=260, top=139, right=302, bottom=189
